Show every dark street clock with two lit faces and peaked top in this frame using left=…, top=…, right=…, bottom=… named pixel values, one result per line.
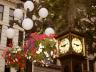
left=58, top=32, right=87, bottom=72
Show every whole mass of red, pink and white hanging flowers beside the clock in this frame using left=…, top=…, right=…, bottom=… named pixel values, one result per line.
left=3, top=32, right=56, bottom=70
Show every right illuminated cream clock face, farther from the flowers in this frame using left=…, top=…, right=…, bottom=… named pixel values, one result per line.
left=72, top=38, right=82, bottom=53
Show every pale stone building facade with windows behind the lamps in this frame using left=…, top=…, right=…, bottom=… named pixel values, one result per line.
left=0, top=0, right=23, bottom=72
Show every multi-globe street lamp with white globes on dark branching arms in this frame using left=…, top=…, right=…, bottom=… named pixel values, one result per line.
left=6, top=1, right=55, bottom=38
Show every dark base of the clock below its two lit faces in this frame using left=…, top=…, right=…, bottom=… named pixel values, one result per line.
left=59, top=55, right=87, bottom=72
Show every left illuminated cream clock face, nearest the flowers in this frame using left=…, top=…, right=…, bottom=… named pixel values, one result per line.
left=59, top=38, right=70, bottom=54
